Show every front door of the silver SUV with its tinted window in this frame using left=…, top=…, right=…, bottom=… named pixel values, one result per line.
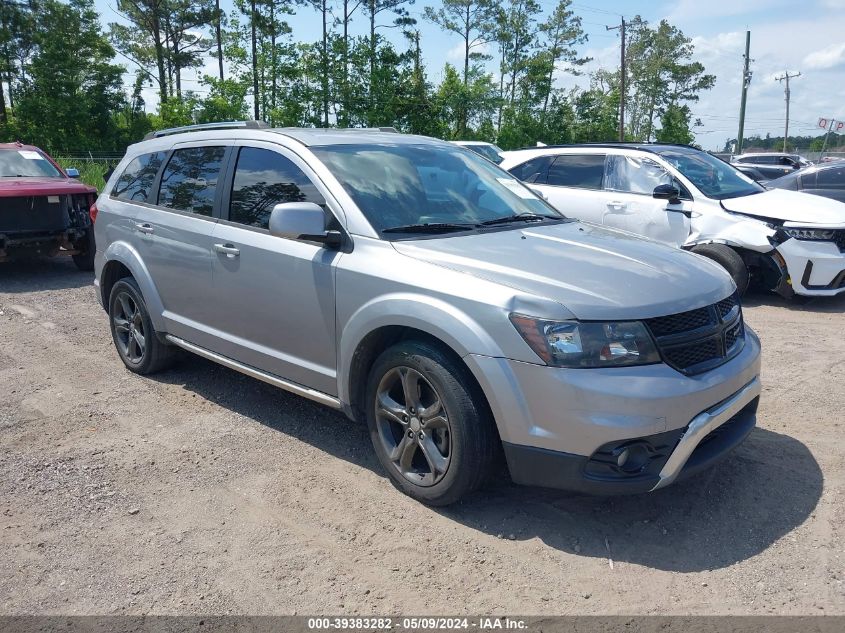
left=210, top=142, right=342, bottom=395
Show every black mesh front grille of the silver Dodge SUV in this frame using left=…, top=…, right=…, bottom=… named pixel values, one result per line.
left=646, top=295, right=745, bottom=374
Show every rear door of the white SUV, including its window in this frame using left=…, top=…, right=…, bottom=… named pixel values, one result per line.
left=526, top=154, right=605, bottom=224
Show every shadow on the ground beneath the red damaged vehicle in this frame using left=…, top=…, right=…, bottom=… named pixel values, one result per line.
left=0, top=257, right=94, bottom=293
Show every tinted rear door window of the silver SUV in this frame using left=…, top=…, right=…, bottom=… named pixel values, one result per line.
left=158, top=147, right=226, bottom=216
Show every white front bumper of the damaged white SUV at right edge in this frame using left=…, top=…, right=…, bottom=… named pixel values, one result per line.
left=777, top=239, right=845, bottom=297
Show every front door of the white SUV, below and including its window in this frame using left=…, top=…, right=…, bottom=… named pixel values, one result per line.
left=603, top=154, right=692, bottom=246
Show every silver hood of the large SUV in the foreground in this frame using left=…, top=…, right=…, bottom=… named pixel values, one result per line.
left=393, top=222, right=734, bottom=320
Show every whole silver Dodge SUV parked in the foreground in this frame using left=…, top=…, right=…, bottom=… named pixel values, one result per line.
left=92, top=123, right=760, bottom=505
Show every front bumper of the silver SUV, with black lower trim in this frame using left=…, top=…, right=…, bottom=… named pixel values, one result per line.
left=465, top=326, right=760, bottom=494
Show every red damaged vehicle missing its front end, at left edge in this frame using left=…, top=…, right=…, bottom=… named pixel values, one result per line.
left=0, top=143, right=97, bottom=270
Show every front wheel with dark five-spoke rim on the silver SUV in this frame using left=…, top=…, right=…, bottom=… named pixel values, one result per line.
left=367, top=341, right=498, bottom=506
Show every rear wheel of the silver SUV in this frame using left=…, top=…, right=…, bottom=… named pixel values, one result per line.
left=109, top=277, right=175, bottom=375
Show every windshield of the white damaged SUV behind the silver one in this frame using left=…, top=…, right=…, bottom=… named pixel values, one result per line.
left=654, top=147, right=765, bottom=200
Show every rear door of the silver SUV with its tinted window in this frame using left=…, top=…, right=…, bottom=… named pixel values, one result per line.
left=133, top=141, right=230, bottom=347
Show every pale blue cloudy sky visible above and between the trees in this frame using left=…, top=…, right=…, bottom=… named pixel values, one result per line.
left=95, top=0, right=845, bottom=150
